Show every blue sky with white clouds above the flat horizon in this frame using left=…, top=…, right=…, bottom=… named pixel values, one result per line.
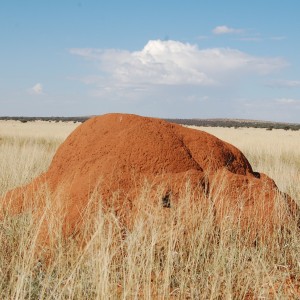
left=0, top=0, right=300, bottom=123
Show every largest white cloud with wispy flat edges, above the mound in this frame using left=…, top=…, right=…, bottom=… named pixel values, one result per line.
left=70, top=40, right=287, bottom=89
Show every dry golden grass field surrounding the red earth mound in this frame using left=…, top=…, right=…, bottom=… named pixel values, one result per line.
left=0, top=121, right=300, bottom=299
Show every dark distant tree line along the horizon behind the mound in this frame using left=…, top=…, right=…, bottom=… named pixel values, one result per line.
left=0, top=116, right=300, bottom=130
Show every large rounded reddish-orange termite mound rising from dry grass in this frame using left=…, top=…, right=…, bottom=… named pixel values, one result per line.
left=0, top=114, right=296, bottom=238
